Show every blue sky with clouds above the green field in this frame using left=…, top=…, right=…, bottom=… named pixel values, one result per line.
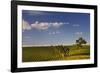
left=22, top=10, right=90, bottom=46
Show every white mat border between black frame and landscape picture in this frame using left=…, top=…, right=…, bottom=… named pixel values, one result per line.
left=17, top=5, right=94, bottom=68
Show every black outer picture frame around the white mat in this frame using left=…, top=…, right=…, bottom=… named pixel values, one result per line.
left=11, top=1, right=97, bottom=72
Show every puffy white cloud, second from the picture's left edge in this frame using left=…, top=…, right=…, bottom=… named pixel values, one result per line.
left=31, top=21, right=49, bottom=30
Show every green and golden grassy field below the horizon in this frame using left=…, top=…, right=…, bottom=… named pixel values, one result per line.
left=22, top=45, right=90, bottom=62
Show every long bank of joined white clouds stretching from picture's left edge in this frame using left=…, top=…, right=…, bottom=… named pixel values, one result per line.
left=22, top=20, right=63, bottom=30
